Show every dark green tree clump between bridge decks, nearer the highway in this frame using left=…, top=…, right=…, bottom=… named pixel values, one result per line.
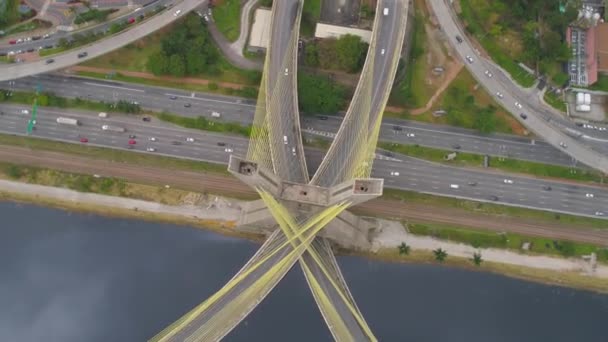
left=298, top=72, right=348, bottom=114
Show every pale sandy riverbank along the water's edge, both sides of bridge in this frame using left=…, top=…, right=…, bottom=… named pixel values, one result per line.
left=0, top=180, right=608, bottom=293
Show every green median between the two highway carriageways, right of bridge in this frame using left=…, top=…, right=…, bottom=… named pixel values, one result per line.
left=378, top=142, right=605, bottom=183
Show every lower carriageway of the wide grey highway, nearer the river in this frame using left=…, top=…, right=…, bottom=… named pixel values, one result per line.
left=0, top=105, right=608, bottom=217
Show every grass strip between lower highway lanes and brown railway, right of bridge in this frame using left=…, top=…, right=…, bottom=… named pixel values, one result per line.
left=382, top=188, right=608, bottom=229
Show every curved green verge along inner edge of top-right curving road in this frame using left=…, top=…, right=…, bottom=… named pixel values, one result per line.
left=460, top=0, right=535, bottom=88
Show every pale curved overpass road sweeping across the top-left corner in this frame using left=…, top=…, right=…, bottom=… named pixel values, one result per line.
left=0, top=0, right=202, bottom=81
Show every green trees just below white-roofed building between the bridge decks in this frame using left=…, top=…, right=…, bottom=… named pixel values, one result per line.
left=304, top=34, right=369, bottom=73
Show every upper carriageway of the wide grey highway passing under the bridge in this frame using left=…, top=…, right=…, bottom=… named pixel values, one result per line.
left=0, top=74, right=580, bottom=166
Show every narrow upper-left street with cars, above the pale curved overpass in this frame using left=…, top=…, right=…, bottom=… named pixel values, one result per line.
left=0, top=0, right=174, bottom=53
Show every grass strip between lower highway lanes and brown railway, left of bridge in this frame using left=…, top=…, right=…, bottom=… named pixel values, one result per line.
left=0, top=134, right=228, bottom=174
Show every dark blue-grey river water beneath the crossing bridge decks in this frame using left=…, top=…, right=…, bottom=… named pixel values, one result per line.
left=0, top=202, right=608, bottom=342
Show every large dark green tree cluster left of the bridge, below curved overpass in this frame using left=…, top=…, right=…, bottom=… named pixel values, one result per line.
left=146, top=15, right=220, bottom=77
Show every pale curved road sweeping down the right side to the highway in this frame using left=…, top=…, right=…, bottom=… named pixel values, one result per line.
left=429, top=0, right=608, bottom=173
